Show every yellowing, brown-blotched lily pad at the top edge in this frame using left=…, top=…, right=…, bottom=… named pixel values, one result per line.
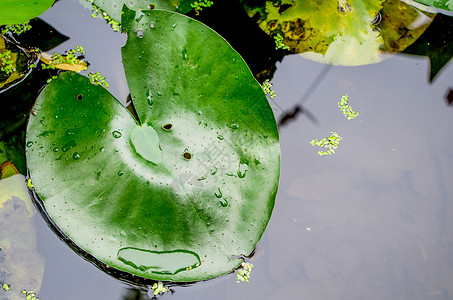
left=242, top=0, right=432, bottom=65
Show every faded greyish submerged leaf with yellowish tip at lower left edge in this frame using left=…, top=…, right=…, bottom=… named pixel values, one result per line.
left=0, top=169, right=44, bottom=300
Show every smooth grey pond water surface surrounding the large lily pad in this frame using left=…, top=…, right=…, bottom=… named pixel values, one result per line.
left=12, top=0, right=453, bottom=300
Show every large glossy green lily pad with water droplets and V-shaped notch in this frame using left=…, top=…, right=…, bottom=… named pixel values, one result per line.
left=26, top=8, right=280, bottom=281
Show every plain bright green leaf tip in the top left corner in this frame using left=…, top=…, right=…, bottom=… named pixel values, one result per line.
left=0, top=0, right=55, bottom=26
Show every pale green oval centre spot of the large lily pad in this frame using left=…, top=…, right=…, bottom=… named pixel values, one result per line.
left=131, top=125, right=162, bottom=165
